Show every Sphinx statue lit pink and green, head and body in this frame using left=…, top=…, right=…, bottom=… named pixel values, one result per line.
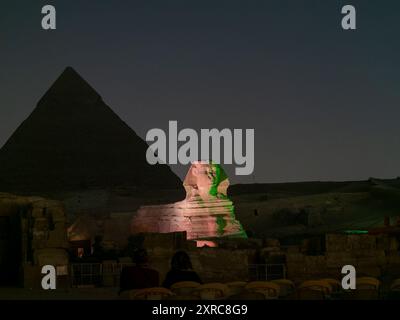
left=131, top=161, right=246, bottom=239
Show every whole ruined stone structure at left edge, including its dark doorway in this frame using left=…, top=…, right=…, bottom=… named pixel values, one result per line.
left=0, top=193, right=69, bottom=288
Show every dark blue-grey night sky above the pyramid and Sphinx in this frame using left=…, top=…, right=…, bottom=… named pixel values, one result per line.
left=0, top=0, right=400, bottom=182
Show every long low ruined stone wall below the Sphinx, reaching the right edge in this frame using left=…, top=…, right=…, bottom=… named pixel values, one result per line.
left=144, top=233, right=400, bottom=282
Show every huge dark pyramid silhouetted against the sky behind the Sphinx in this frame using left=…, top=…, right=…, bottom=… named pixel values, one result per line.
left=0, top=67, right=182, bottom=192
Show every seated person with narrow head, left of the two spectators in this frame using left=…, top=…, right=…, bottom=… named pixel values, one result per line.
left=120, top=249, right=159, bottom=293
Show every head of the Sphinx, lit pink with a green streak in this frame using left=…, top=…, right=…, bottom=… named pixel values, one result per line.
left=183, top=161, right=229, bottom=200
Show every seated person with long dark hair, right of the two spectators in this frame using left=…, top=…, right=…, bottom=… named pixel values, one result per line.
left=163, top=251, right=202, bottom=289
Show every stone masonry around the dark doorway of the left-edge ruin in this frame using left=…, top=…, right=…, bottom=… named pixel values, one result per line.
left=0, top=194, right=69, bottom=287
